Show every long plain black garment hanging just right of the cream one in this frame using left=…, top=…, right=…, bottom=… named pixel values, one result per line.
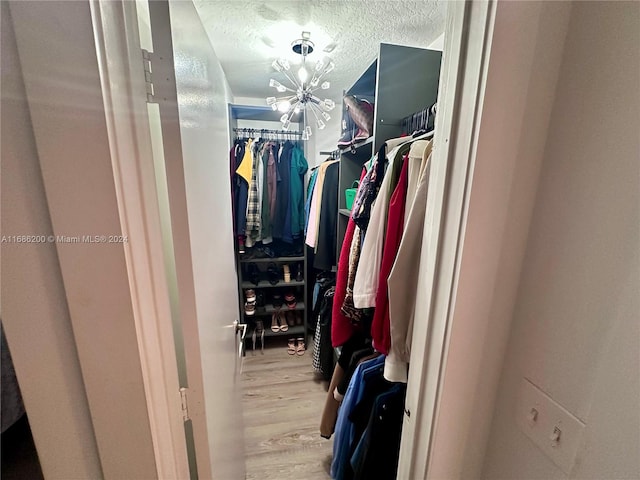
left=313, top=162, right=340, bottom=270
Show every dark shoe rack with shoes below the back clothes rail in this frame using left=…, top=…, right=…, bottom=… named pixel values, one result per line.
left=237, top=253, right=308, bottom=351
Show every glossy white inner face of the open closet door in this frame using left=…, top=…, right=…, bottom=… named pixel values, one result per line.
left=170, top=2, right=244, bottom=479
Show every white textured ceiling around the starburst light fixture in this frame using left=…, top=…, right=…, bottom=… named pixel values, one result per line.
left=194, top=0, right=446, bottom=103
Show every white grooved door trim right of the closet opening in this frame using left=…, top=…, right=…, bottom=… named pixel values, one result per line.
left=398, top=1, right=495, bottom=479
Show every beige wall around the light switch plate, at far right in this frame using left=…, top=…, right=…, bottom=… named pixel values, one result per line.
left=483, top=2, right=640, bottom=479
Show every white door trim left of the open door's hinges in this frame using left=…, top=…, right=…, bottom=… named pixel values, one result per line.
left=90, top=0, right=189, bottom=479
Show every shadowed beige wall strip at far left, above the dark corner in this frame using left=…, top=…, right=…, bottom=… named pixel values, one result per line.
left=0, top=2, right=102, bottom=479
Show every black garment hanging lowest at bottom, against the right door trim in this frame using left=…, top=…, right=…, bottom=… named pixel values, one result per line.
left=350, top=384, right=406, bottom=480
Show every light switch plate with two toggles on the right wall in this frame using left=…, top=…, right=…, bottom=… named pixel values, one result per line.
left=516, top=378, right=585, bottom=474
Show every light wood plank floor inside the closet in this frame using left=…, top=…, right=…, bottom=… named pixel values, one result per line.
left=242, top=338, right=333, bottom=480
